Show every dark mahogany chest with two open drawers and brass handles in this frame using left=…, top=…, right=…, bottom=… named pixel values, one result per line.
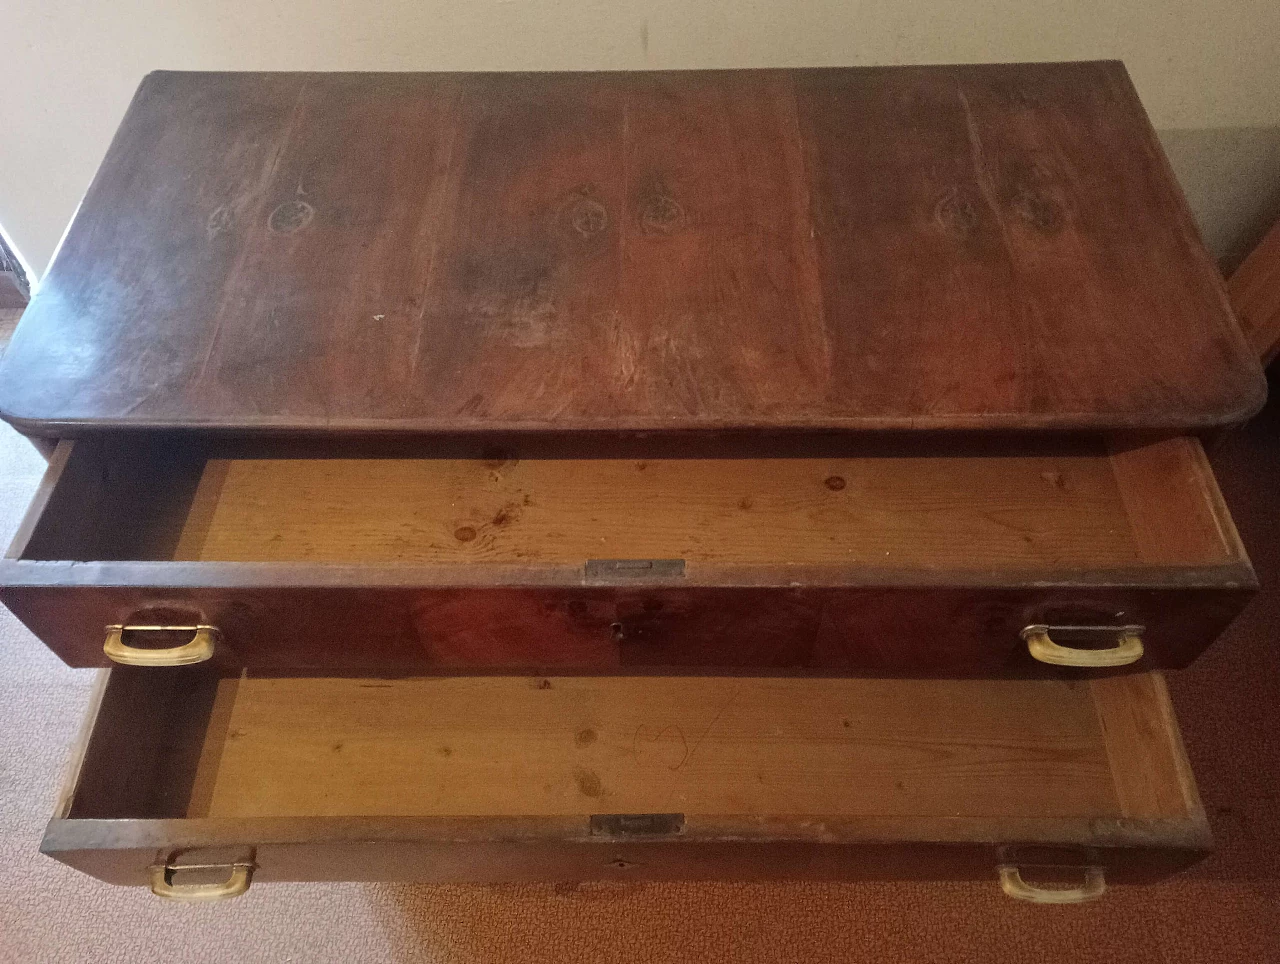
left=0, top=64, right=1263, bottom=901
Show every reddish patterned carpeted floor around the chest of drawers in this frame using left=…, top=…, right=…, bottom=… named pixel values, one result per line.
left=0, top=304, right=1280, bottom=964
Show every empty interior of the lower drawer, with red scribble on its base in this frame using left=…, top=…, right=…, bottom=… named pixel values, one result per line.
left=63, top=667, right=1203, bottom=835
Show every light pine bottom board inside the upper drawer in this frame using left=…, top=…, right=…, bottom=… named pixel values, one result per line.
left=162, top=453, right=1152, bottom=568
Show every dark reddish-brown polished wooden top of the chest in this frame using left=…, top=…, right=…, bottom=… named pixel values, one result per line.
left=0, top=63, right=1265, bottom=435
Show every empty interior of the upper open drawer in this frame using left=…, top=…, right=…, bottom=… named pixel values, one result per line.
left=10, top=438, right=1244, bottom=570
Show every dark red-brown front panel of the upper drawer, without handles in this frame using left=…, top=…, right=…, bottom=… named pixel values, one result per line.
left=0, top=576, right=1249, bottom=676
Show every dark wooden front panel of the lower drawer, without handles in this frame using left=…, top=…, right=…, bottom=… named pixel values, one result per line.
left=42, top=821, right=1206, bottom=886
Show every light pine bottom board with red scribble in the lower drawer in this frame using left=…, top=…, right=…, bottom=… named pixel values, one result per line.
left=180, top=677, right=1121, bottom=818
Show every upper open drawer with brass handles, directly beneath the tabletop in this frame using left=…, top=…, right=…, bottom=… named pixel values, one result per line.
left=0, top=437, right=1256, bottom=677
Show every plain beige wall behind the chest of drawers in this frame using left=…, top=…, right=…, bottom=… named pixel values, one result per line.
left=0, top=0, right=1280, bottom=271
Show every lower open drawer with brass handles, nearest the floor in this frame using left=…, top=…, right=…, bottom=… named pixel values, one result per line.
left=42, top=667, right=1210, bottom=900
